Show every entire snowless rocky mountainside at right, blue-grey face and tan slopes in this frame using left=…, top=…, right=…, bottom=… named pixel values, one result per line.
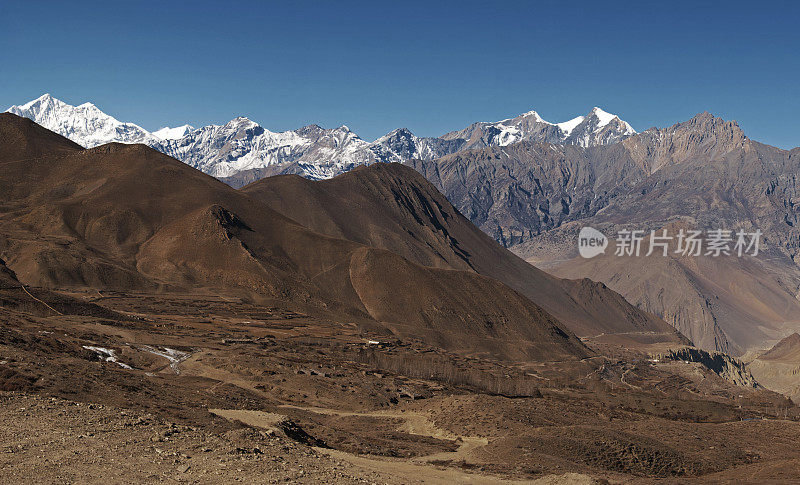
left=398, top=113, right=800, bottom=354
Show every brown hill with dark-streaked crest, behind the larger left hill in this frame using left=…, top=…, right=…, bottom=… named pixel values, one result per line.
left=241, top=163, right=683, bottom=342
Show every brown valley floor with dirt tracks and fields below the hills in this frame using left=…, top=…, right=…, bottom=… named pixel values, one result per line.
left=0, top=291, right=800, bottom=483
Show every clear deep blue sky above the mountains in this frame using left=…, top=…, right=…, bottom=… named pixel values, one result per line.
left=0, top=0, right=800, bottom=148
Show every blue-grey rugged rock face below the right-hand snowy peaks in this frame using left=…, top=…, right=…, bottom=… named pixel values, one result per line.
left=405, top=142, right=647, bottom=247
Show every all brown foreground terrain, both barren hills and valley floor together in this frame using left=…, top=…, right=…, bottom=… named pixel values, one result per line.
left=0, top=114, right=800, bottom=484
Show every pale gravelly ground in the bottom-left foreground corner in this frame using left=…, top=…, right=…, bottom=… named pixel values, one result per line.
left=0, top=392, right=396, bottom=483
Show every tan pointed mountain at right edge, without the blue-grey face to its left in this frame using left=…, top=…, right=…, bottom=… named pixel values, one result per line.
left=514, top=113, right=800, bottom=355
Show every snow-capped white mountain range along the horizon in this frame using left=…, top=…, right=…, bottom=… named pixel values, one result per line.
left=3, top=94, right=636, bottom=186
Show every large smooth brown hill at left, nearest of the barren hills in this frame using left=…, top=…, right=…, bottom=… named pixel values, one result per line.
left=0, top=114, right=589, bottom=360
